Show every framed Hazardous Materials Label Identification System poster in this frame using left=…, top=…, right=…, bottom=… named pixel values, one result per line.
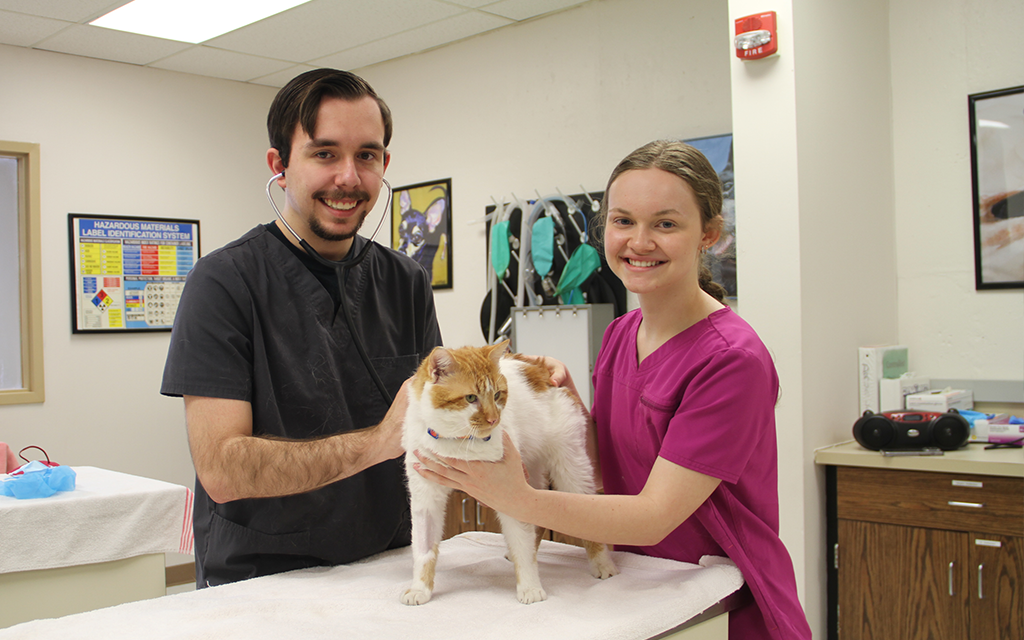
left=68, top=213, right=200, bottom=334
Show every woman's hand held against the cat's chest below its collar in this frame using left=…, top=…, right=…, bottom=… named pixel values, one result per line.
left=413, top=425, right=534, bottom=517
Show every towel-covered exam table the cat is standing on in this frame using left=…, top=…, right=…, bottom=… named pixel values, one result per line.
left=0, top=531, right=749, bottom=640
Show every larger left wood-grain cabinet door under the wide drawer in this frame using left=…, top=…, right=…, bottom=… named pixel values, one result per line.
left=838, top=519, right=966, bottom=640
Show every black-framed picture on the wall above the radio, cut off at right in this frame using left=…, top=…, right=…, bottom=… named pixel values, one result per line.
left=968, top=86, right=1024, bottom=289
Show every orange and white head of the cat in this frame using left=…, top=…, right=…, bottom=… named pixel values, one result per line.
left=414, top=340, right=508, bottom=439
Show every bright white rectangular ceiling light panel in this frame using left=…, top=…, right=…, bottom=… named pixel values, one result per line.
left=89, top=0, right=309, bottom=44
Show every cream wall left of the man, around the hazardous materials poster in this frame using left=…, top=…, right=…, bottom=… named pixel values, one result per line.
left=0, top=45, right=274, bottom=486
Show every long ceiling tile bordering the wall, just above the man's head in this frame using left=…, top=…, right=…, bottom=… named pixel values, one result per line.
left=311, top=11, right=512, bottom=71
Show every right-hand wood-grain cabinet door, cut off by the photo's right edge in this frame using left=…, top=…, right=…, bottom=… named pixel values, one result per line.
left=968, top=534, right=1024, bottom=640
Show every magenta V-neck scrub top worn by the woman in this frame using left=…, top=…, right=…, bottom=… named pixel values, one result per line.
left=593, top=307, right=811, bottom=640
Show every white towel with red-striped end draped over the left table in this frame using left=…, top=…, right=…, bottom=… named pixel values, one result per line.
left=0, top=467, right=193, bottom=573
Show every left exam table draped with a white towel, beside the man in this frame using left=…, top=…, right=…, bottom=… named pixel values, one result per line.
left=0, top=467, right=193, bottom=629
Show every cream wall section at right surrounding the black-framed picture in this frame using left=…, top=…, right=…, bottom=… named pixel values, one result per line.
left=890, top=0, right=1024, bottom=378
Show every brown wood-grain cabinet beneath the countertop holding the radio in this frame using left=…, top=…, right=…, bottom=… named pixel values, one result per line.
left=828, top=466, right=1024, bottom=640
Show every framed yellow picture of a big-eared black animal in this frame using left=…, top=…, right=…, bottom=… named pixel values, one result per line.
left=391, top=178, right=452, bottom=289
